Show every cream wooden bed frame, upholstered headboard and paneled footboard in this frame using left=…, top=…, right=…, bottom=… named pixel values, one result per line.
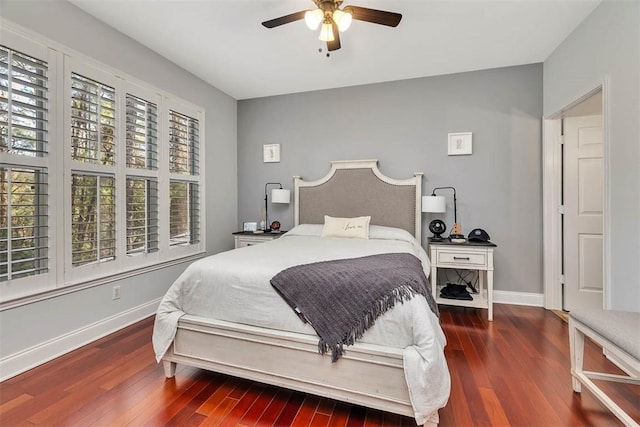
left=163, top=160, right=438, bottom=426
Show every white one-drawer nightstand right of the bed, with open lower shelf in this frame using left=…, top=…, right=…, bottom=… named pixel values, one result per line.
left=429, top=240, right=496, bottom=320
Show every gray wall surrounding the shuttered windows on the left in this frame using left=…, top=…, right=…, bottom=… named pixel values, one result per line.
left=0, top=0, right=237, bottom=358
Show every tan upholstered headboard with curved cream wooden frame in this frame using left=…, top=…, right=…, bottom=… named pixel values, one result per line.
left=294, top=160, right=422, bottom=242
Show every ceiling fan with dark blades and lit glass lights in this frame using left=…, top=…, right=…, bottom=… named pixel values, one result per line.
left=262, top=0, right=402, bottom=51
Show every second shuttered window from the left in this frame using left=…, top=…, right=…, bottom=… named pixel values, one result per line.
left=68, top=72, right=118, bottom=274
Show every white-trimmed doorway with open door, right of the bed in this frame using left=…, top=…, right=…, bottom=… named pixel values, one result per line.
left=543, top=85, right=609, bottom=311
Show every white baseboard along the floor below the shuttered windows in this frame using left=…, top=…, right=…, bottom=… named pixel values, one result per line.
left=0, top=298, right=160, bottom=382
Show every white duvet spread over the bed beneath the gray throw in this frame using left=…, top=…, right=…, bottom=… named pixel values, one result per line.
left=153, top=224, right=450, bottom=425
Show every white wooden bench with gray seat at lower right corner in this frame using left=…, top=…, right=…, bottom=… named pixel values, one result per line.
left=569, top=310, right=640, bottom=426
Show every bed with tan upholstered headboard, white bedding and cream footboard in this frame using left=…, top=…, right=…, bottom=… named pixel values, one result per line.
left=153, top=160, right=450, bottom=425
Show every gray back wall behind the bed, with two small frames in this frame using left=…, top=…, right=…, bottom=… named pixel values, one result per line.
left=238, top=64, right=542, bottom=293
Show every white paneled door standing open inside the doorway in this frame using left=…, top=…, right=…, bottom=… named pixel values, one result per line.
left=563, top=113, right=604, bottom=311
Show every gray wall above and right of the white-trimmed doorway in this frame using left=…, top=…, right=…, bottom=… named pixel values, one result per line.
left=544, top=0, right=640, bottom=311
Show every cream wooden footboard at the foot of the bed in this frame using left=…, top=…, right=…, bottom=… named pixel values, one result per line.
left=163, top=315, right=424, bottom=425
